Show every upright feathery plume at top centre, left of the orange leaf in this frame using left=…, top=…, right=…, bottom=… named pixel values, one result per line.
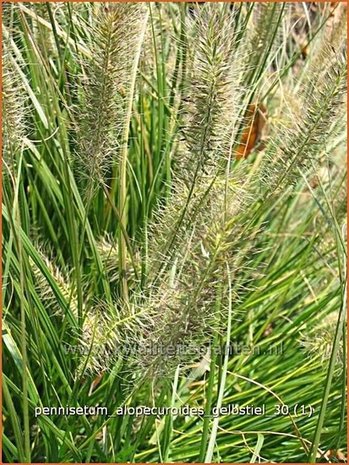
left=174, top=3, right=241, bottom=183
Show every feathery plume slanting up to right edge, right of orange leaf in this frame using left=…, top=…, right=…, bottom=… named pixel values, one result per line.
left=261, top=42, right=347, bottom=194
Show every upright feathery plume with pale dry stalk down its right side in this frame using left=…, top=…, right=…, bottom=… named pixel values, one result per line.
left=78, top=3, right=148, bottom=302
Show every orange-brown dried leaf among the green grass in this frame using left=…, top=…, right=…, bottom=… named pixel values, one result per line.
left=235, top=103, right=267, bottom=160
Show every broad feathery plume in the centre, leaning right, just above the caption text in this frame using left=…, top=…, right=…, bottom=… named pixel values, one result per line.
left=132, top=171, right=252, bottom=375
